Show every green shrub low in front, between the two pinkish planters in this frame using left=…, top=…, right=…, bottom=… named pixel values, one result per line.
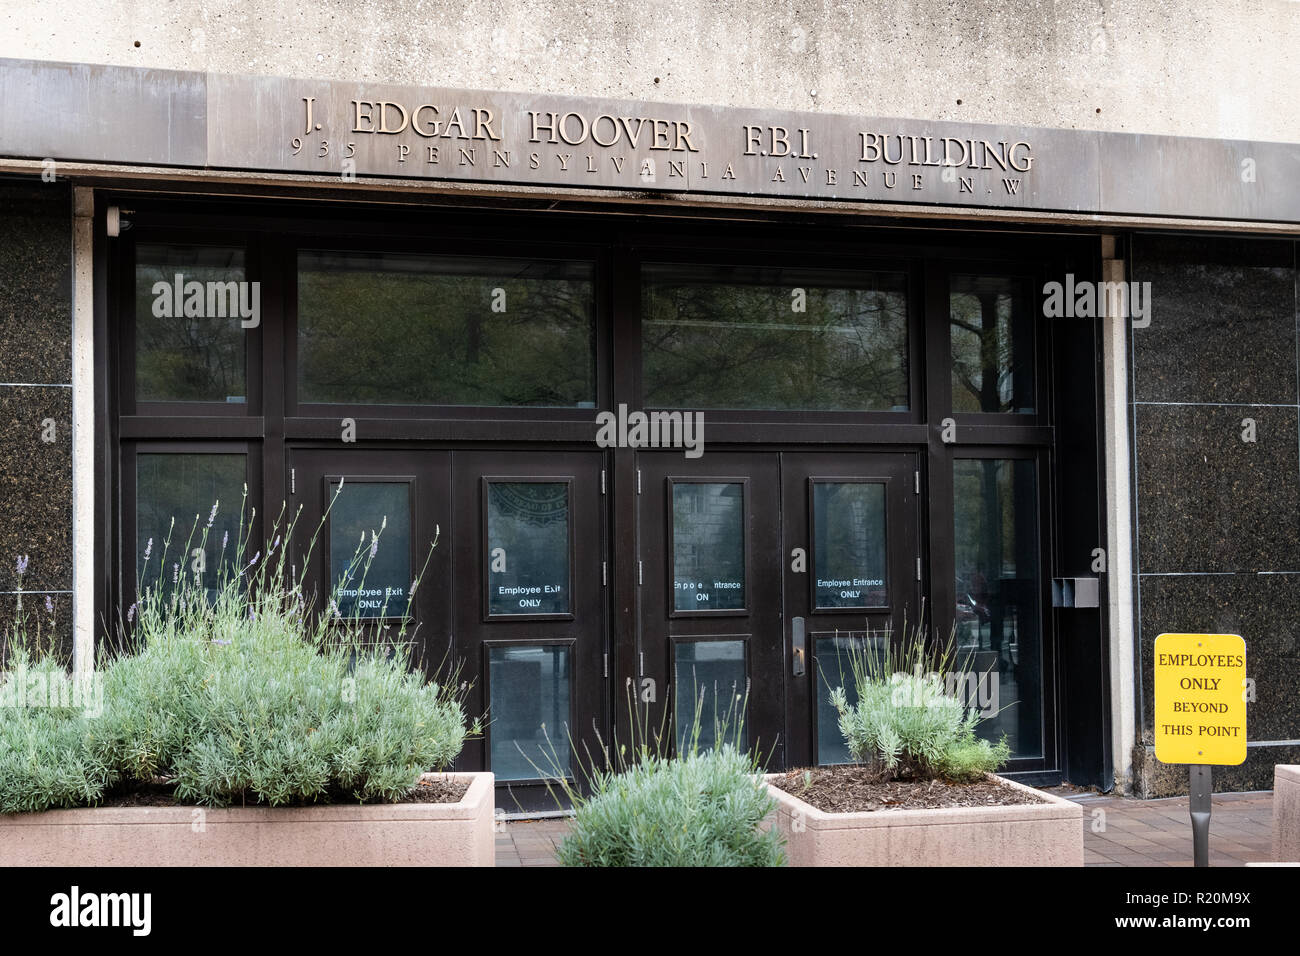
left=558, top=743, right=785, bottom=866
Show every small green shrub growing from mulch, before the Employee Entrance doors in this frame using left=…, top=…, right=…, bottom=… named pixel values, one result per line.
left=831, top=627, right=1010, bottom=782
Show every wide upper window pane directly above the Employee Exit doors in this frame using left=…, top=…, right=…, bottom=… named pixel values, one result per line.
left=298, top=252, right=595, bottom=406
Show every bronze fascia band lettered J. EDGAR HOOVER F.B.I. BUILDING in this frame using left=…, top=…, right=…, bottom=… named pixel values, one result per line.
left=0, top=60, right=1300, bottom=222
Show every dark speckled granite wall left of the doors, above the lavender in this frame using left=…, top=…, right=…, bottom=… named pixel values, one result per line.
left=0, top=179, right=73, bottom=659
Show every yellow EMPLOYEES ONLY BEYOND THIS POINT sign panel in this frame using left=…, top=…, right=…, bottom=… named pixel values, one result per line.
left=1156, top=633, right=1247, bottom=766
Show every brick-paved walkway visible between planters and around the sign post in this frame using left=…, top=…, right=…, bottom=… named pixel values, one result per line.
left=497, top=792, right=1273, bottom=866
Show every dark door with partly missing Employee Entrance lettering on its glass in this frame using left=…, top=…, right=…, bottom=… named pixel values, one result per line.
left=637, top=453, right=785, bottom=765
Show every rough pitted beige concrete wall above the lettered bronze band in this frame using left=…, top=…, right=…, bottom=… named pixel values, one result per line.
left=0, top=0, right=1300, bottom=142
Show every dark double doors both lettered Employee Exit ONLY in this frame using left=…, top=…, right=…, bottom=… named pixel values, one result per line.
left=290, top=450, right=608, bottom=813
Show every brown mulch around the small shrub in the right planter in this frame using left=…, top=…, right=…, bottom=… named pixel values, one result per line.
left=771, top=763, right=1050, bottom=813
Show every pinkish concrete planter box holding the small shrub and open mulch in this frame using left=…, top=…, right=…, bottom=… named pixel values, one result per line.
left=767, top=774, right=1083, bottom=866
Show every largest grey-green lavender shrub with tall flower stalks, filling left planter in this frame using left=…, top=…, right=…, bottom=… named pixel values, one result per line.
left=0, top=494, right=469, bottom=813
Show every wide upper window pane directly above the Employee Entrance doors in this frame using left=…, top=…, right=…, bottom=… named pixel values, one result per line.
left=641, top=265, right=907, bottom=410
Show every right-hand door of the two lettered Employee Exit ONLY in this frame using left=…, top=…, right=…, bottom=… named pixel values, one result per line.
left=449, top=451, right=608, bottom=813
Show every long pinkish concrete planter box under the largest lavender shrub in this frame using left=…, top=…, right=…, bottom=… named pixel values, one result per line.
left=0, top=774, right=495, bottom=866
